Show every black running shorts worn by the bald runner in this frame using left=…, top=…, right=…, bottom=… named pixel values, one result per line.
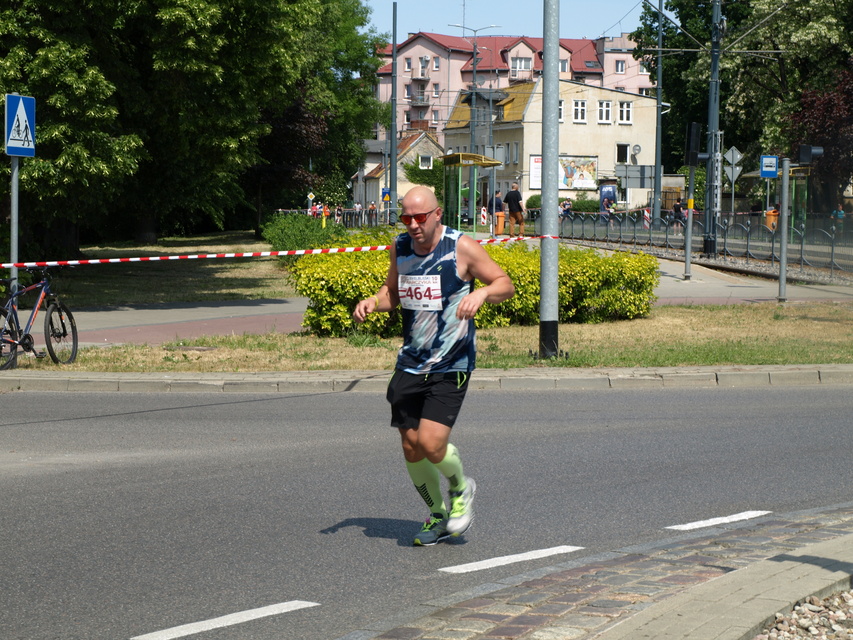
left=385, top=369, right=471, bottom=429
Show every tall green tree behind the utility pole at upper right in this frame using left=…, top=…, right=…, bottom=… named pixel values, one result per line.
left=632, top=0, right=853, bottom=180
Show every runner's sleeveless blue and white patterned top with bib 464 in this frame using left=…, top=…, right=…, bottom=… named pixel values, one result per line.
left=395, top=226, right=476, bottom=374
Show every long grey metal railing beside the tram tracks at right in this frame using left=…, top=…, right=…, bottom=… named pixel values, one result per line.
left=528, top=210, right=853, bottom=272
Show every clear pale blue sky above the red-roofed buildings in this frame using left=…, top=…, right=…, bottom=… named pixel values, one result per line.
left=364, top=0, right=644, bottom=42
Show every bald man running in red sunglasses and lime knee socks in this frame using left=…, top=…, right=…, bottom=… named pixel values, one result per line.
left=353, top=186, right=515, bottom=546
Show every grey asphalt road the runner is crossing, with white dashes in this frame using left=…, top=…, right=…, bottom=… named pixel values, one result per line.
left=0, top=385, right=853, bottom=640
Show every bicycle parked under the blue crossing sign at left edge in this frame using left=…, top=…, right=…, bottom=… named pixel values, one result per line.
left=0, top=267, right=77, bottom=369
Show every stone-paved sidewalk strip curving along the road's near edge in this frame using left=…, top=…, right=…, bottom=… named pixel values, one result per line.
left=339, top=503, right=853, bottom=640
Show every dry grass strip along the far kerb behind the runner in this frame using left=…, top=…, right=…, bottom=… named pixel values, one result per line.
left=19, top=303, right=853, bottom=372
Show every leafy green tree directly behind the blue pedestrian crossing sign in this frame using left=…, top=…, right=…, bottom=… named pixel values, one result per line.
left=0, top=0, right=144, bottom=259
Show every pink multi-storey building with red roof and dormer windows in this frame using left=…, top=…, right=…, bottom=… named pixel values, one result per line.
left=377, top=32, right=653, bottom=145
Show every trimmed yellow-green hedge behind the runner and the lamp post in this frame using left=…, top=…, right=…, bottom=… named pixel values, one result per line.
left=291, top=237, right=659, bottom=337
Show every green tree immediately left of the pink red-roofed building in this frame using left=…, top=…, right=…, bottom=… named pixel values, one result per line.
left=241, top=0, right=390, bottom=219
